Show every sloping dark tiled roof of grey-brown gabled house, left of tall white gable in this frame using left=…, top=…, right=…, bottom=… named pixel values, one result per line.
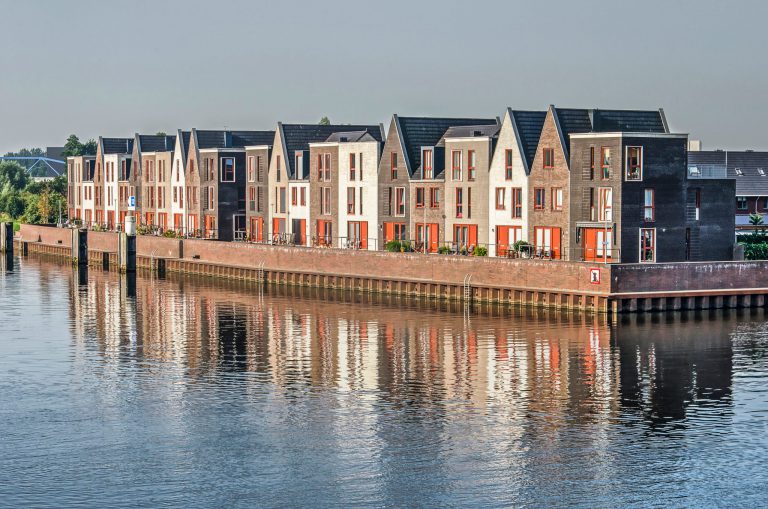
left=393, top=115, right=498, bottom=175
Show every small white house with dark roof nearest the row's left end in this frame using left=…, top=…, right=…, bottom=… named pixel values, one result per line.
left=93, top=136, right=133, bottom=230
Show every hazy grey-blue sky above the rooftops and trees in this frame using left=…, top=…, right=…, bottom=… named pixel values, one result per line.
left=0, top=0, right=768, bottom=152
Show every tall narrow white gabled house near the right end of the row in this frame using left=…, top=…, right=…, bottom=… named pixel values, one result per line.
left=488, top=108, right=547, bottom=256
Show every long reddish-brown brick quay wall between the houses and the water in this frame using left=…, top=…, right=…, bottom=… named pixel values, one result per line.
left=17, top=225, right=768, bottom=313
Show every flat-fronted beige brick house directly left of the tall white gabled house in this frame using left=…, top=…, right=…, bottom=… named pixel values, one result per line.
left=438, top=123, right=500, bottom=253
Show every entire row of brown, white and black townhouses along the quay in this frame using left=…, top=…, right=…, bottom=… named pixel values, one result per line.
left=68, top=106, right=736, bottom=263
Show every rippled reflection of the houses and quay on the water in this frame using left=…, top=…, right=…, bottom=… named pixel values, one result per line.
left=64, top=260, right=733, bottom=433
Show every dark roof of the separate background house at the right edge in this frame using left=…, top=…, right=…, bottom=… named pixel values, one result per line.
left=688, top=150, right=768, bottom=196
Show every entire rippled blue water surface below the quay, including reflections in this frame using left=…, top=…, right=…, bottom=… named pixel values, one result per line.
left=0, top=257, right=768, bottom=508
